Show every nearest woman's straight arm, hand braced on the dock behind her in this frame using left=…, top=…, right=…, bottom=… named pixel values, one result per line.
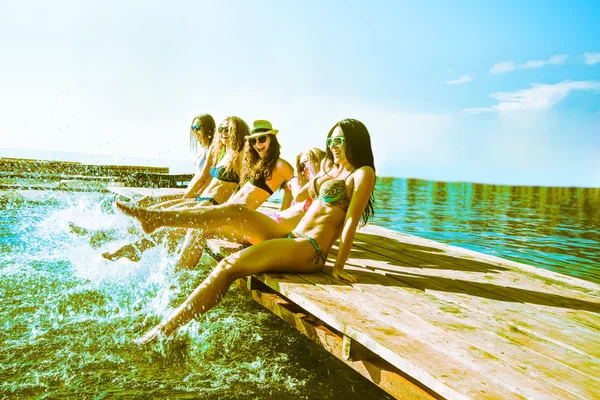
left=333, top=167, right=375, bottom=283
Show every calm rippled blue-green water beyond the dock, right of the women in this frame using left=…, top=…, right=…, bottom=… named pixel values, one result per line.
left=373, top=178, right=600, bottom=282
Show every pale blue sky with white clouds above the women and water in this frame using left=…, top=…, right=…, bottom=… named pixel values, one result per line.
left=0, top=0, right=600, bottom=187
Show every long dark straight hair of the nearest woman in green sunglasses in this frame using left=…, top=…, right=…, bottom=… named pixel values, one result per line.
left=327, top=118, right=375, bottom=226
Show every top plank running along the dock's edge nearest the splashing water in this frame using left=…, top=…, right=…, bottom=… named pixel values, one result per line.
left=257, top=274, right=522, bottom=399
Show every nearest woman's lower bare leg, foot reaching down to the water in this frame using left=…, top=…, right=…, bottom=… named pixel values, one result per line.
left=136, top=236, right=322, bottom=344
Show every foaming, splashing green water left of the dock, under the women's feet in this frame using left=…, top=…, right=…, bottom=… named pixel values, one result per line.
left=0, top=192, right=381, bottom=399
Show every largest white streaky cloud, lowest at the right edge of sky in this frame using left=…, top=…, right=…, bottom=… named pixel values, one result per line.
left=464, top=81, right=600, bottom=114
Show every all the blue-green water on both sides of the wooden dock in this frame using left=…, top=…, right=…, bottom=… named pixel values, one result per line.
left=0, top=178, right=600, bottom=399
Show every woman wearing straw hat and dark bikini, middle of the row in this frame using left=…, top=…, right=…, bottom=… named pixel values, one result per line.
left=175, top=120, right=294, bottom=270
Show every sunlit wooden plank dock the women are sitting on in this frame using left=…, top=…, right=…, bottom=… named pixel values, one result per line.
left=109, top=188, right=600, bottom=400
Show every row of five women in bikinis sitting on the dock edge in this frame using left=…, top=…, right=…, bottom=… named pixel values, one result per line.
left=104, top=114, right=375, bottom=343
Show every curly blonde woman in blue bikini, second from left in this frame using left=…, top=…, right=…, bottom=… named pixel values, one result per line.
left=102, top=117, right=250, bottom=261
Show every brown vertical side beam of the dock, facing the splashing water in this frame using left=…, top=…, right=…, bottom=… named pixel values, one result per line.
left=236, top=279, right=441, bottom=399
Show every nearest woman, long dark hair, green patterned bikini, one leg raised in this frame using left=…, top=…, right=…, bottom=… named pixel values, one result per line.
left=117, top=119, right=375, bottom=343
